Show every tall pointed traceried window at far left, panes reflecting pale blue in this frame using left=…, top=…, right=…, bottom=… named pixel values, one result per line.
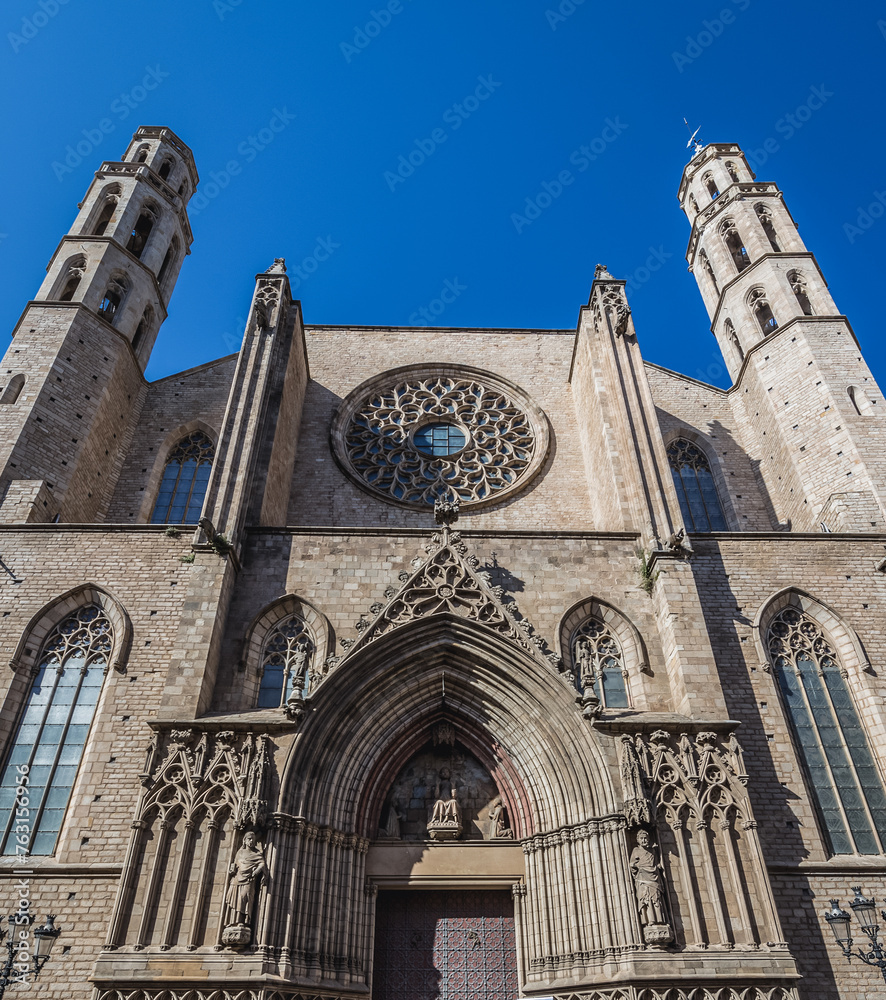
left=0, top=604, right=113, bottom=854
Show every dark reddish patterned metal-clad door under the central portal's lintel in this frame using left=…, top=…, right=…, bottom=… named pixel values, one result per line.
left=372, top=890, right=517, bottom=1000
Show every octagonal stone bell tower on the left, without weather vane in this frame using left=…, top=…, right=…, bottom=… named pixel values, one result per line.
left=0, top=126, right=198, bottom=523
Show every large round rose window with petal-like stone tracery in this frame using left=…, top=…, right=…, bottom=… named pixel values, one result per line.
left=332, top=366, right=548, bottom=508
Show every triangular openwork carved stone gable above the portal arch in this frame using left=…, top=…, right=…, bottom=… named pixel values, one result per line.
left=336, top=527, right=559, bottom=669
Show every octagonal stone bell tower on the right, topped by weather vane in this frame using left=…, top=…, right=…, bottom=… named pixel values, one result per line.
left=678, top=143, right=886, bottom=531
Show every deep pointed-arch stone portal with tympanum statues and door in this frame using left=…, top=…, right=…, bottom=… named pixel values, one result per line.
left=268, top=614, right=639, bottom=1000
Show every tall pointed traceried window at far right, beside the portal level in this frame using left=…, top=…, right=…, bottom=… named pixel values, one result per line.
left=767, top=607, right=886, bottom=854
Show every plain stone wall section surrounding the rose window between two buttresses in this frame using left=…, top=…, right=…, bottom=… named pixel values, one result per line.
left=288, top=326, right=596, bottom=529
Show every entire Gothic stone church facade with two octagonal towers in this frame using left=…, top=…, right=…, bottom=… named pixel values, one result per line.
left=0, top=127, right=886, bottom=1000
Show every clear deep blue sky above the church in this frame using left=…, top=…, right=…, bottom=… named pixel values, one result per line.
left=0, top=0, right=886, bottom=385
